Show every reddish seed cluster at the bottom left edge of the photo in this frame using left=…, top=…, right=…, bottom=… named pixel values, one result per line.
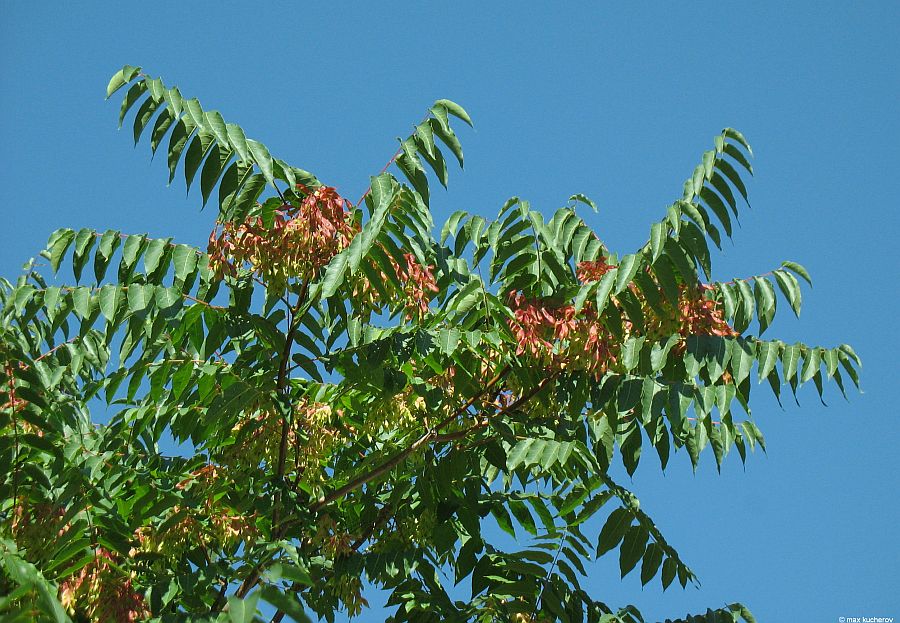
left=59, top=547, right=150, bottom=623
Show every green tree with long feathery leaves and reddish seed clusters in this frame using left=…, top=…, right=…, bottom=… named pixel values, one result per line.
left=0, top=66, right=860, bottom=622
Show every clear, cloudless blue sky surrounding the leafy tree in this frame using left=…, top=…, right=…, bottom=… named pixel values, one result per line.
left=0, top=0, right=900, bottom=622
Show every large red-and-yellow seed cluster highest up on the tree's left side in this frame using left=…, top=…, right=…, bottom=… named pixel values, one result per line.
left=209, top=184, right=357, bottom=287
